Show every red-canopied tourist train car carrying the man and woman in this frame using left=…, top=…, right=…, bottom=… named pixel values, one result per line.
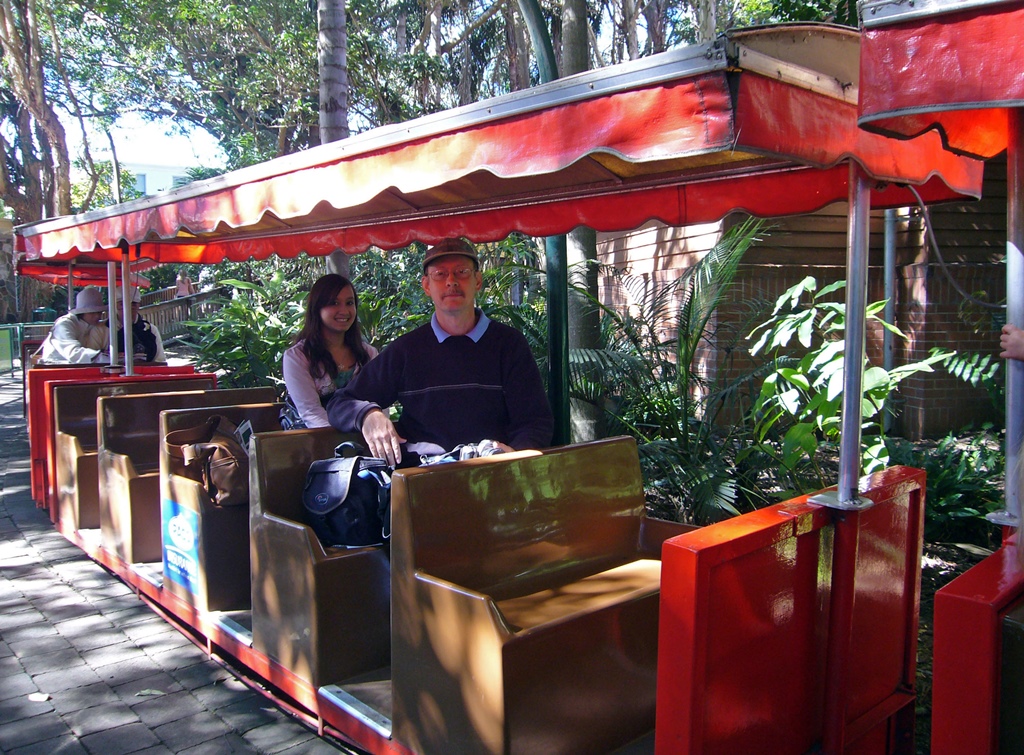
left=17, top=25, right=982, bottom=753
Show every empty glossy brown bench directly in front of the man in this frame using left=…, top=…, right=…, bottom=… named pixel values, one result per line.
left=391, top=437, right=692, bottom=754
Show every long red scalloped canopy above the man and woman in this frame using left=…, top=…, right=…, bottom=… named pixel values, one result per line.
left=17, top=29, right=982, bottom=263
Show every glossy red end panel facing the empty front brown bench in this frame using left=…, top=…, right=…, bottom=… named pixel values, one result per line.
left=655, top=467, right=925, bottom=755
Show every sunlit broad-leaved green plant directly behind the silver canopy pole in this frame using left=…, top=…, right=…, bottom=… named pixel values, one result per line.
left=741, top=277, right=952, bottom=497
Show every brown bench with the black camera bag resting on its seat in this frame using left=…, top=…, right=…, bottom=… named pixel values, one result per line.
left=249, top=427, right=391, bottom=687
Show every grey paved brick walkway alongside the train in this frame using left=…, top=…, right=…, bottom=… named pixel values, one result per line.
left=0, top=372, right=348, bottom=755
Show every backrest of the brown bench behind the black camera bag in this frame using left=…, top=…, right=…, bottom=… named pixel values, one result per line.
left=249, top=427, right=362, bottom=522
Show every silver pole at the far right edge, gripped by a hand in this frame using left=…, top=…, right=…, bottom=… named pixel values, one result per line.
left=988, top=108, right=1024, bottom=527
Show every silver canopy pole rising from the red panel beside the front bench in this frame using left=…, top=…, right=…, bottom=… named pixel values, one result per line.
left=810, top=160, right=871, bottom=509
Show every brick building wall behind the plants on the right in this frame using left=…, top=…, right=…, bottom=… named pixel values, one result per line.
left=599, top=159, right=1007, bottom=439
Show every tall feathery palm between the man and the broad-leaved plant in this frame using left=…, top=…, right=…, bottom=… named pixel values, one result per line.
left=557, top=220, right=764, bottom=523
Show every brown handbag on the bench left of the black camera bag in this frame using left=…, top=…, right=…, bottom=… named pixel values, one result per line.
left=164, top=414, right=249, bottom=506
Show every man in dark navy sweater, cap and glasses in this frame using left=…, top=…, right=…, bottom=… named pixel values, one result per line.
left=327, top=239, right=554, bottom=465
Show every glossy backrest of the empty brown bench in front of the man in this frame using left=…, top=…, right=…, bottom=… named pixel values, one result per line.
left=391, top=437, right=644, bottom=600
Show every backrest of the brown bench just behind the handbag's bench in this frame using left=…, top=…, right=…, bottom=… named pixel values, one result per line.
left=96, top=387, right=276, bottom=467
